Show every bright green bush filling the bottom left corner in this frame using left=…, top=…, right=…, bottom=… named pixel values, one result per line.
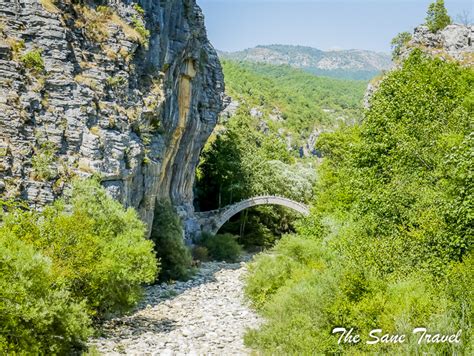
left=0, top=228, right=92, bottom=354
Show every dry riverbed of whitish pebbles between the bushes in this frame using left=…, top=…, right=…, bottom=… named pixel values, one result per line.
left=90, top=256, right=260, bottom=355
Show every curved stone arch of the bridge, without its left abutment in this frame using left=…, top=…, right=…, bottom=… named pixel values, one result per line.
left=206, top=195, right=309, bottom=235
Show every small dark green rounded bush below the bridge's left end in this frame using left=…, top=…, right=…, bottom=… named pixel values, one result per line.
left=200, top=234, right=242, bottom=262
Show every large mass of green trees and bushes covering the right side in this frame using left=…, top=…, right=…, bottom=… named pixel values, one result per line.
left=246, top=50, right=474, bottom=354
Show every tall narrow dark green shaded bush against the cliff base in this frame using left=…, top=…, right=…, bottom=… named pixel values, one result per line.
left=151, top=202, right=192, bottom=281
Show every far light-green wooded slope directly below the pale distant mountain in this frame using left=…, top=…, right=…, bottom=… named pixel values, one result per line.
left=223, top=61, right=367, bottom=137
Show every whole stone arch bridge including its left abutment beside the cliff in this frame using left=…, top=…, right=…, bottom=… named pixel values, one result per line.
left=192, top=195, right=309, bottom=239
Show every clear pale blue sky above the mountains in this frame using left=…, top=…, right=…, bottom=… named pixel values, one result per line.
left=197, top=0, right=474, bottom=52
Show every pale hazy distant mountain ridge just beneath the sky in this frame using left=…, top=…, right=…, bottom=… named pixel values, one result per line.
left=219, top=45, right=392, bottom=80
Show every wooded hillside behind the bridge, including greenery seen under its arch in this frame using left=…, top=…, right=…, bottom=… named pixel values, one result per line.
left=197, top=61, right=367, bottom=246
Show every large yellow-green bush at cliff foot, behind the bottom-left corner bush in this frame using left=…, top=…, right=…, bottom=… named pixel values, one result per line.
left=0, top=180, right=157, bottom=318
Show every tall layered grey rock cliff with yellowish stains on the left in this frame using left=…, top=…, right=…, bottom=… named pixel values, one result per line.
left=0, top=0, right=224, bottom=235
